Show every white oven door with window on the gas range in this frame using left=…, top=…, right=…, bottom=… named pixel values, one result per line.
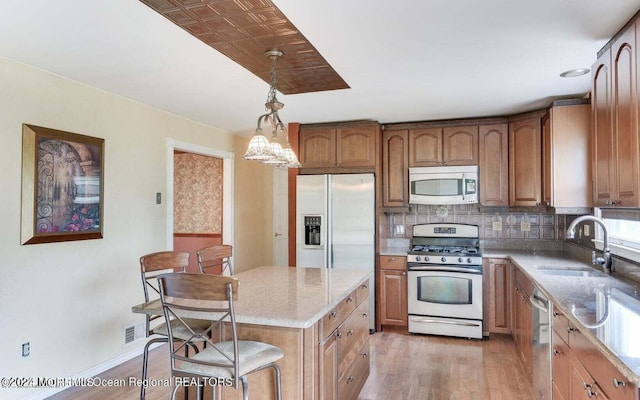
left=407, top=266, right=482, bottom=320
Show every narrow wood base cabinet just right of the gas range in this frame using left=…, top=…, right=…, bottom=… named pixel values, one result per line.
left=483, top=258, right=513, bottom=334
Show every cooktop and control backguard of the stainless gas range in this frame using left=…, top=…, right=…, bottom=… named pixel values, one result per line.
left=407, top=224, right=482, bottom=265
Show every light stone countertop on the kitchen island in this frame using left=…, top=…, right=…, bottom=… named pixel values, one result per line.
left=131, top=266, right=373, bottom=328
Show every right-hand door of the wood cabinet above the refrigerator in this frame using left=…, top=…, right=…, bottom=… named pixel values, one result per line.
left=336, top=126, right=379, bottom=167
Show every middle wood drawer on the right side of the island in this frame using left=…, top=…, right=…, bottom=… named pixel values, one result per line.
left=337, top=302, right=369, bottom=377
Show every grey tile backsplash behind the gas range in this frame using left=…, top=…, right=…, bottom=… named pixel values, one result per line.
left=380, top=204, right=565, bottom=249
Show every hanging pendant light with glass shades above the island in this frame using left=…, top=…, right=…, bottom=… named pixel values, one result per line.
left=242, top=50, right=302, bottom=168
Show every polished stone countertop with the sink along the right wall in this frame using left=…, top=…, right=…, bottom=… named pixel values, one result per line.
left=482, top=249, right=640, bottom=386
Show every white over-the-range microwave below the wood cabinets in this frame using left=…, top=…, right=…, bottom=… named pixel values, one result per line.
left=409, top=165, right=478, bottom=204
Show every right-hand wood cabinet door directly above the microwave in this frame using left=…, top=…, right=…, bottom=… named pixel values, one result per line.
left=442, top=125, right=478, bottom=165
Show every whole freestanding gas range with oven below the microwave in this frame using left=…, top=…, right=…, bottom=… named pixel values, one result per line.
left=407, top=224, right=483, bottom=338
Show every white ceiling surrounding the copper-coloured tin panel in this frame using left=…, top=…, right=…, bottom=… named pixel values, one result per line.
left=0, top=0, right=640, bottom=134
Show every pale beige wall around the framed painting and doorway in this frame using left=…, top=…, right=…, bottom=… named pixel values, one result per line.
left=0, top=58, right=272, bottom=399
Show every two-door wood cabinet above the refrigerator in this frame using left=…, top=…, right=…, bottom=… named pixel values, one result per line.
left=299, top=123, right=380, bottom=169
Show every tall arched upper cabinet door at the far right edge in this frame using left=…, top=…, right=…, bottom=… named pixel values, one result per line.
left=611, top=26, right=639, bottom=207
